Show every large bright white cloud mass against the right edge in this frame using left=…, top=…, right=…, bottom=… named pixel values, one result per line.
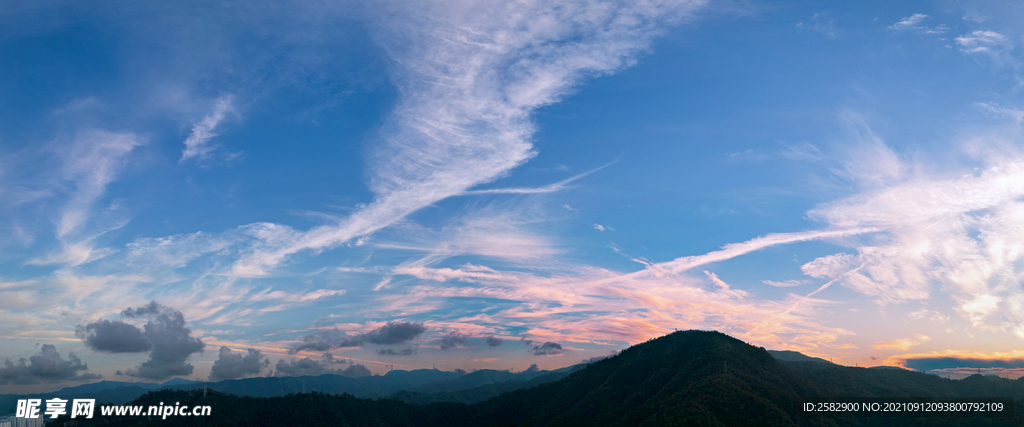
left=803, top=133, right=1024, bottom=331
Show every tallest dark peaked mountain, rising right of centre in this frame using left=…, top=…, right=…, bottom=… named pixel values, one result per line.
left=471, top=331, right=835, bottom=426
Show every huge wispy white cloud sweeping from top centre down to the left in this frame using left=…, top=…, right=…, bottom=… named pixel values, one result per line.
left=220, top=0, right=703, bottom=277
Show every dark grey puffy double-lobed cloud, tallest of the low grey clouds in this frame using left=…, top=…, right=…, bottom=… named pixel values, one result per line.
left=84, top=301, right=206, bottom=380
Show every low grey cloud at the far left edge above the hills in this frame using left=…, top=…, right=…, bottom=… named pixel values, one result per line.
left=0, top=344, right=100, bottom=384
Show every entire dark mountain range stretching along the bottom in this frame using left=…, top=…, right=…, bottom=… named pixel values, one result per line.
left=8, top=331, right=1024, bottom=427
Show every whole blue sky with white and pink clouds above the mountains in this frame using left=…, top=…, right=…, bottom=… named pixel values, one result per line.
left=0, top=0, right=1024, bottom=393
